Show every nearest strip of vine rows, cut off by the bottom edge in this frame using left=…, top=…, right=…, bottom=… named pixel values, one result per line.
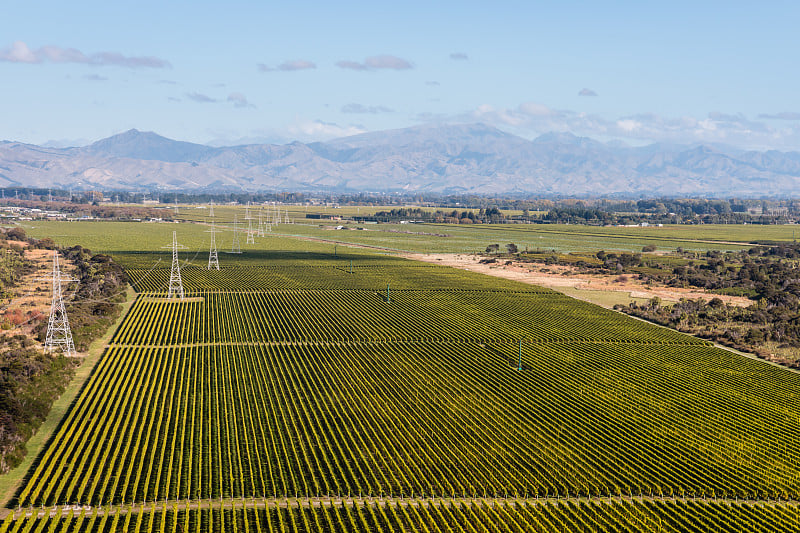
left=0, top=500, right=800, bottom=533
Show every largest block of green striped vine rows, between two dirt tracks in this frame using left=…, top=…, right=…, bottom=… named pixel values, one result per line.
left=19, top=344, right=800, bottom=505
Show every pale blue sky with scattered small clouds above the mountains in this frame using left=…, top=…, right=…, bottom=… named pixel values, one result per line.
left=0, top=0, right=800, bottom=151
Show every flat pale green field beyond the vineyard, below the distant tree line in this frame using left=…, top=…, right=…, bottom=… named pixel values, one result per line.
left=18, top=216, right=796, bottom=259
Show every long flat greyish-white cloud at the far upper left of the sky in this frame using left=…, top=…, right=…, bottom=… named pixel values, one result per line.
left=0, top=41, right=171, bottom=68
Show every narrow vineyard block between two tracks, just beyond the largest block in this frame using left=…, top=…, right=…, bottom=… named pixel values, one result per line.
left=109, top=291, right=705, bottom=345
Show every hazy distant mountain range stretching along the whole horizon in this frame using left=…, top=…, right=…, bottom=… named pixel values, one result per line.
left=0, top=124, right=800, bottom=196
